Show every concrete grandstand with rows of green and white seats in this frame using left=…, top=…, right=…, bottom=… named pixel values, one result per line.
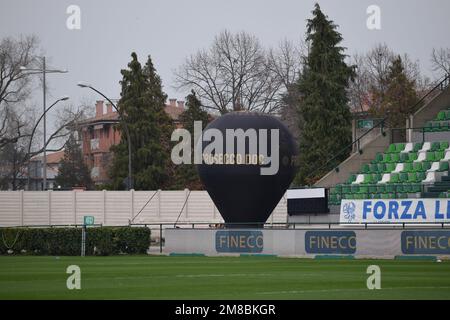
left=315, top=76, right=450, bottom=213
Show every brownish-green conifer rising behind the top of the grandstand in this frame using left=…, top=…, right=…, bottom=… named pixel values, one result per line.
left=370, top=56, right=419, bottom=132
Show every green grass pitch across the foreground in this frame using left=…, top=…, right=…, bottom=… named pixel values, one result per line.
left=0, top=256, right=450, bottom=300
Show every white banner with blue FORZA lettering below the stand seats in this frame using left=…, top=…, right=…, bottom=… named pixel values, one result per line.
left=340, top=199, right=450, bottom=224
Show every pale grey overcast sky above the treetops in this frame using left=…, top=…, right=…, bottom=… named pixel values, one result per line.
left=0, top=0, right=450, bottom=131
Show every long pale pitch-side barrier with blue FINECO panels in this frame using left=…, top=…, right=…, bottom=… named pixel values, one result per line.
left=149, top=222, right=450, bottom=258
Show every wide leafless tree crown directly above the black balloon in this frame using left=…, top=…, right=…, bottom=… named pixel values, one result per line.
left=175, top=31, right=300, bottom=113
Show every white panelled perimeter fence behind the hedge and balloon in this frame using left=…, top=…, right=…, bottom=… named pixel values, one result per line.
left=0, top=190, right=287, bottom=227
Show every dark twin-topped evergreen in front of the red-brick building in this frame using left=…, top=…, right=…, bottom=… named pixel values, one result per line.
left=110, top=52, right=173, bottom=190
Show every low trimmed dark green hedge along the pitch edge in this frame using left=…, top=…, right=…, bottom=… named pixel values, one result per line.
left=0, top=227, right=150, bottom=256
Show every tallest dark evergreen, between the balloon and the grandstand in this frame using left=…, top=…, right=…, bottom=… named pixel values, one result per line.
left=296, top=4, right=354, bottom=184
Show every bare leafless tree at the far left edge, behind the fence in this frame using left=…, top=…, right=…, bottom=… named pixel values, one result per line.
left=0, top=36, right=88, bottom=189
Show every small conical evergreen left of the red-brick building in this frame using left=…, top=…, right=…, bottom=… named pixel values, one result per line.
left=55, top=134, right=93, bottom=189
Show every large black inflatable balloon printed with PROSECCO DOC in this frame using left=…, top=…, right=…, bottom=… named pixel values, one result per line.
left=197, top=112, right=297, bottom=227
